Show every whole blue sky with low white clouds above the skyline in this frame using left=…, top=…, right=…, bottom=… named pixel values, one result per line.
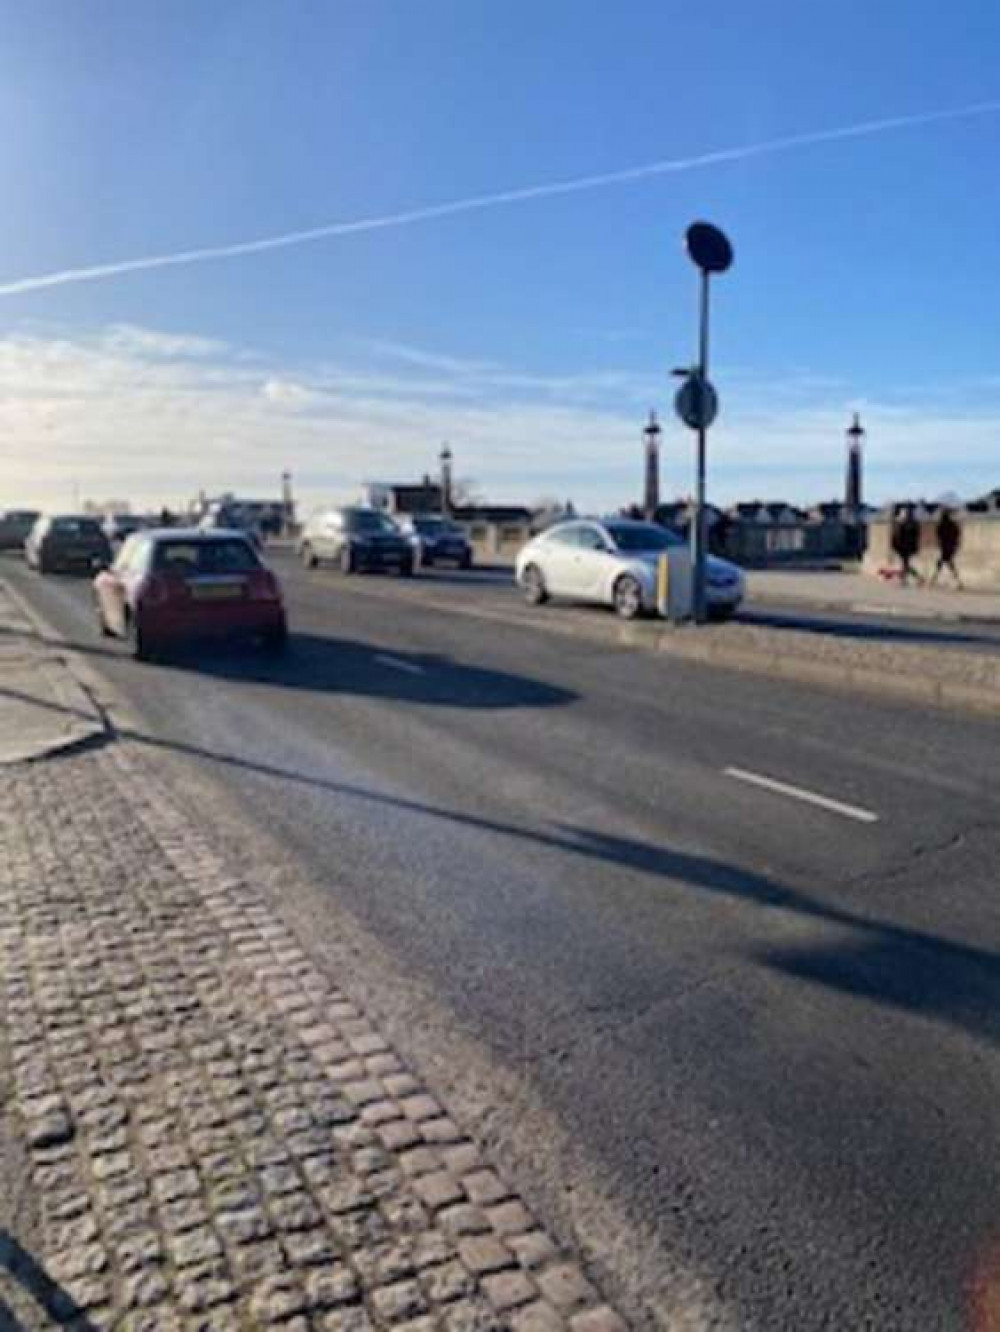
left=0, top=0, right=1000, bottom=509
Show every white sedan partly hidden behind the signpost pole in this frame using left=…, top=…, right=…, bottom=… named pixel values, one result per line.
left=515, top=518, right=746, bottom=619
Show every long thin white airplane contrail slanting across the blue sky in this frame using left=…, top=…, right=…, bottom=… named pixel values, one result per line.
left=0, top=100, right=1000, bottom=296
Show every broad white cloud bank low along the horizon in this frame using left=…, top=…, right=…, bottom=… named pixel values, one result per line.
left=0, top=326, right=1000, bottom=507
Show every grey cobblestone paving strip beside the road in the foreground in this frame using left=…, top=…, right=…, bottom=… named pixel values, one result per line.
left=0, top=745, right=625, bottom=1332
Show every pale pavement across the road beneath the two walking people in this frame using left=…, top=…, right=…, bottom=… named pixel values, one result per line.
left=747, top=569, right=1000, bottom=625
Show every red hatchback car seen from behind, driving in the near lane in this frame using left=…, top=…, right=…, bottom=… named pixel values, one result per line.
left=93, top=527, right=288, bottom=659
